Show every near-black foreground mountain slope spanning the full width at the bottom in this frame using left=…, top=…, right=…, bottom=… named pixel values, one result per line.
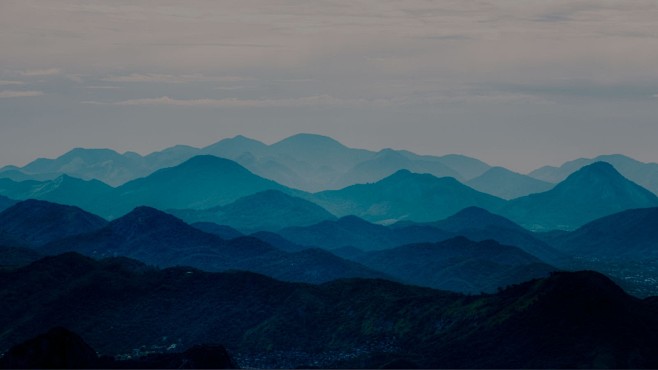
left=0, top=254, right=658, bottom=368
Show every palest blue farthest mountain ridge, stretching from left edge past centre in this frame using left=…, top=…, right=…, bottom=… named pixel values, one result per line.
left=0, top=134, right=488, bottom=191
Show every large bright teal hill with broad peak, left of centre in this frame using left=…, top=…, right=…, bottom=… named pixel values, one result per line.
left=101, top=155, right=287, bottom=218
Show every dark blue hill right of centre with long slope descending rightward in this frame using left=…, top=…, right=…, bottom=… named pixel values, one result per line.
left=429, top=207, right=567, bottom=266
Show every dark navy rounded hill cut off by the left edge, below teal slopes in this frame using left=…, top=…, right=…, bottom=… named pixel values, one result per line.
left=0, top=199, right=107, bottom=247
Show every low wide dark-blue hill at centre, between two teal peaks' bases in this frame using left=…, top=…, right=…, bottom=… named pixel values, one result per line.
left=278, top=216, right=454, bottom=250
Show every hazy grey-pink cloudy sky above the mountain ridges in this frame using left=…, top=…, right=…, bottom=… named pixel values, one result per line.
left=0, top=0, right=658, bottom=172
